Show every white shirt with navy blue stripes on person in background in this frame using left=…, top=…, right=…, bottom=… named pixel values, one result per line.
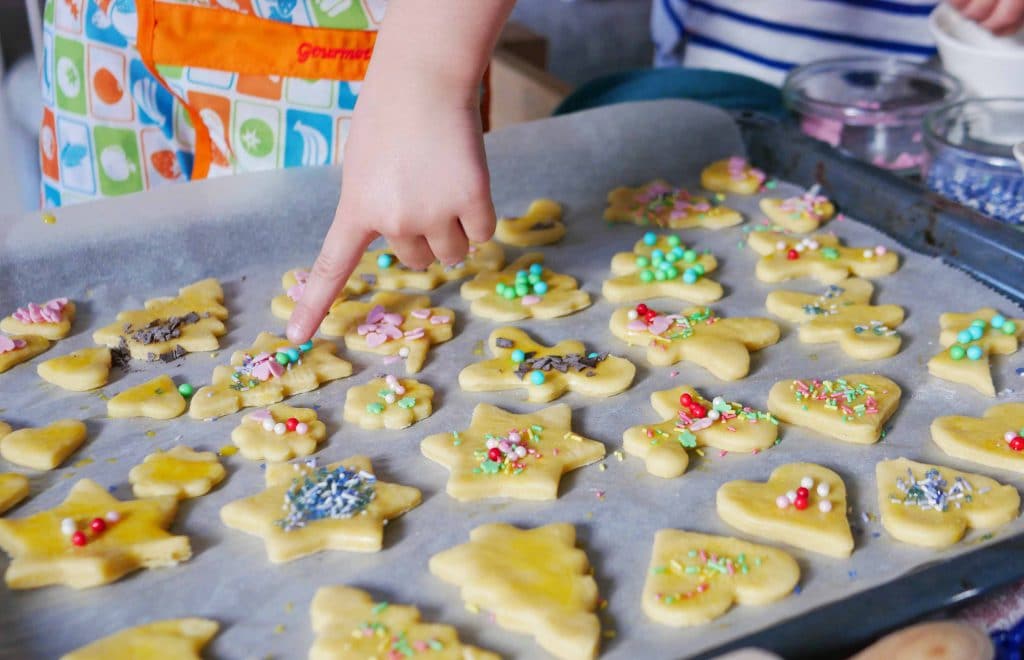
left=651, top=0, right=937, bottom=84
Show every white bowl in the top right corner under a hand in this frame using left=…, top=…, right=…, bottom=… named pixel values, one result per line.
left=928, top=3, right=1024, bottom=96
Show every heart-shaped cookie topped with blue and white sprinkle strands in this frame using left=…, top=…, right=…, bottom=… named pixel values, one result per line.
left=874, top=458, right=1020, bottom=547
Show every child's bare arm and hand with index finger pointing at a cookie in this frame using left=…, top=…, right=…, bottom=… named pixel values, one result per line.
left=288, top=0, right=515, bottom=344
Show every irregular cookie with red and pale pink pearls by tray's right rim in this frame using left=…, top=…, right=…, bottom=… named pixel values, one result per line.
left=746, top=231, right=899, bottom=284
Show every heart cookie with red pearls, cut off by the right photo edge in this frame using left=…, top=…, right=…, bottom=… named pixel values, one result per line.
left=932, top=403, right=1024, bottom=474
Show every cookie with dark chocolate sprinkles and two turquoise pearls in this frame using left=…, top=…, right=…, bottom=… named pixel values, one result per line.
left=459, top=326, right=636, bottom=403
